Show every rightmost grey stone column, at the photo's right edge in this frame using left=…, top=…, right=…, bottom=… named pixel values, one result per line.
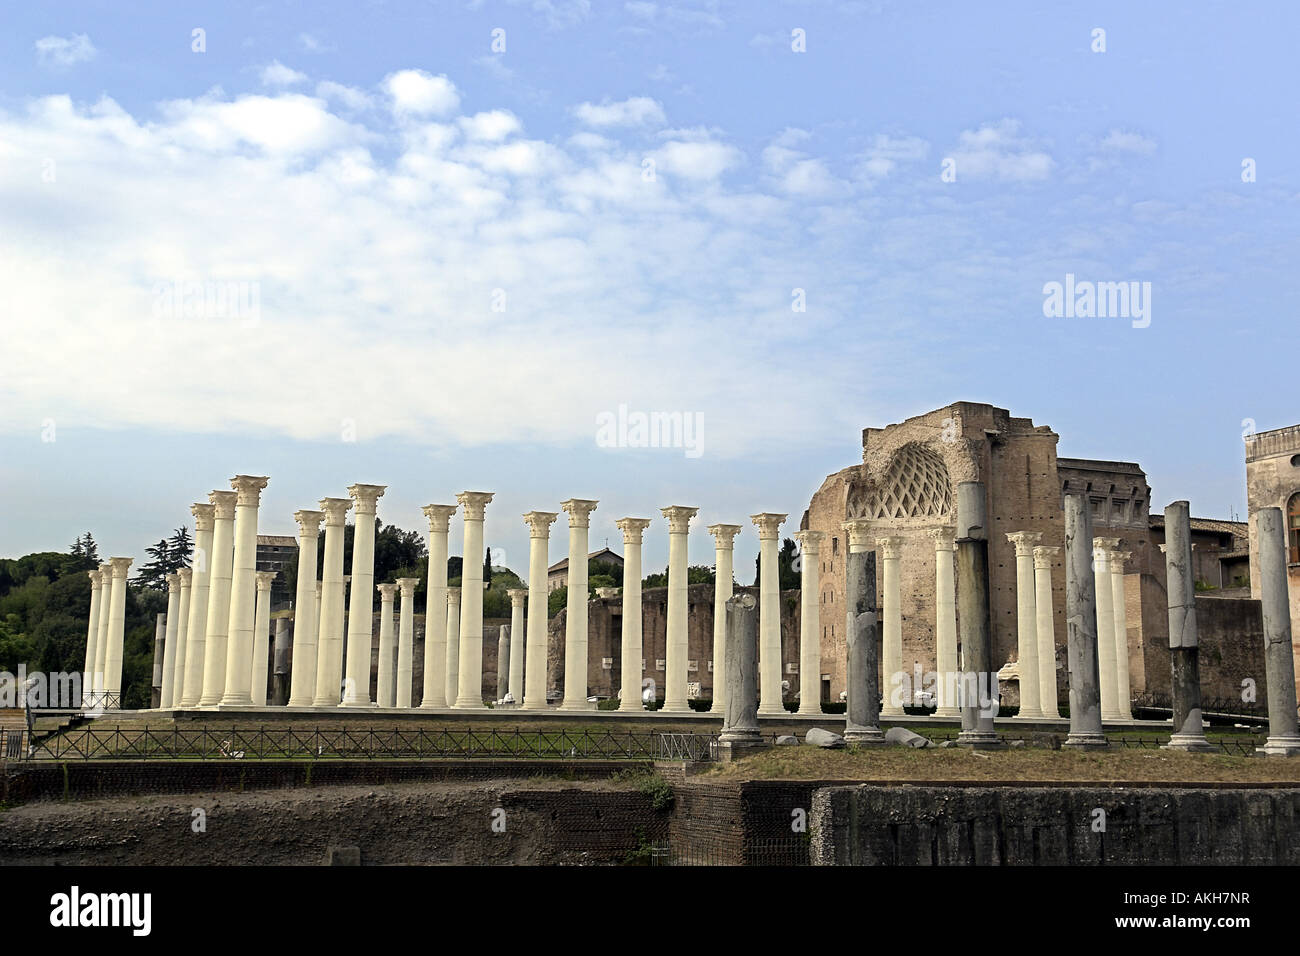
left=1253, top=507, right=1300, bottom=757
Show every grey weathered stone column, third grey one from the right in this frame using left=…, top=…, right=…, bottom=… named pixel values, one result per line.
left=1062, top=494, right=1110, bottom=748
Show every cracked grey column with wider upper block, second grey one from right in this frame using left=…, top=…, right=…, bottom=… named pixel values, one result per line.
left=1162, top=501, right=1211, bottom=752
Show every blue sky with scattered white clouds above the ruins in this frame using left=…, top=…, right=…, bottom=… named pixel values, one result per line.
left=0, top=0, right=1300, bottom=580
